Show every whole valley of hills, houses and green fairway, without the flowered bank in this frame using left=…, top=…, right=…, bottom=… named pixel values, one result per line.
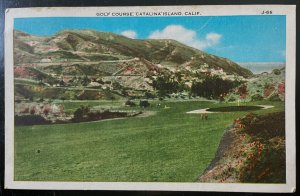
left=13, top=30, right=285, bottom=182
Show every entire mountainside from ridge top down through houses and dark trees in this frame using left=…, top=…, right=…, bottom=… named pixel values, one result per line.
left=14, top=30, right=253, bottom=98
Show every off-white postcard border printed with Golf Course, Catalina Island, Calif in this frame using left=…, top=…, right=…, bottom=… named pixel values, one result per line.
left=4, top=5, right=296, bottom=192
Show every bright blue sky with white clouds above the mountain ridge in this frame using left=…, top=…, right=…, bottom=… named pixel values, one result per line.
left=14, top=15, right=286, bottom=62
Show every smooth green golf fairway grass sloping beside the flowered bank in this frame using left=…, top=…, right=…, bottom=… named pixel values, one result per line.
left=15, top=101, right=284, bottom=182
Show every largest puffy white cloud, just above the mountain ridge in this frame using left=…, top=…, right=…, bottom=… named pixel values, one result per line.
left=149, top=25, right=222, bottom=50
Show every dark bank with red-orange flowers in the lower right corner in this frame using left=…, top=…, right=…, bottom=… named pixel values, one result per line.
left=198, top=112, right=286, bottom=183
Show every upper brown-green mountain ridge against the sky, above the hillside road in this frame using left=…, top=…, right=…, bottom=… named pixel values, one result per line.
left=14, top=30, right=252, bottom=77
